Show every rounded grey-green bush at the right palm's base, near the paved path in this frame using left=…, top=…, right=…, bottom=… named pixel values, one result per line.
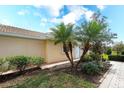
left=81, top=62, right=100, bottom=75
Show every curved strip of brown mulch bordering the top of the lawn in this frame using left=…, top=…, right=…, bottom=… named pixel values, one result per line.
left=0, top=62, right=112, bottom=87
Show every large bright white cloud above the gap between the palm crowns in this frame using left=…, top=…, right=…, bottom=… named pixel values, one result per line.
left=62, top=6, right=94, bottom=24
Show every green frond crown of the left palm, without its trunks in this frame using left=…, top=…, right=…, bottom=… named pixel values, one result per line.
left=51, top=23, right=74, bottom=44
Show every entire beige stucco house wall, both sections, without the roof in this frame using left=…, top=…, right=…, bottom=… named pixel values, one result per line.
left=0, top=36, right=79, bottom=63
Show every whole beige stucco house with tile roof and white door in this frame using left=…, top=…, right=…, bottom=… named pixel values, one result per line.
left=0, top=25, right=80, bottom=63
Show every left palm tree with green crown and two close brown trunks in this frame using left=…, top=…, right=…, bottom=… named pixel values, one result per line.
left=51, top=23, right=75, bottom=68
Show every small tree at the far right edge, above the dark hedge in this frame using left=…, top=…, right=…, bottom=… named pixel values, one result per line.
left=112, top=41, right=124, bottom=55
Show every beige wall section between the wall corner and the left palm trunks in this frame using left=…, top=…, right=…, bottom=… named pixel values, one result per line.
left=46, top=40, right=67, bottom=63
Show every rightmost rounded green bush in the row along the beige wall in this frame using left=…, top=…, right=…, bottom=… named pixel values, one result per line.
left=29, top=56, right=44, bottom=67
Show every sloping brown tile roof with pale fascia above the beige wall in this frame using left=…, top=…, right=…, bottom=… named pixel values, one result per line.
left=0, top=24, right=46, bottom=39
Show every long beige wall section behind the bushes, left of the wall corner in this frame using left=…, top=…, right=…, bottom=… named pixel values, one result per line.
left=0, top=36, right=46, bottom=58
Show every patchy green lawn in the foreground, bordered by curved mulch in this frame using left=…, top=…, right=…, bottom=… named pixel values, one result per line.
left=11, top=72, right=95, bottom=88
